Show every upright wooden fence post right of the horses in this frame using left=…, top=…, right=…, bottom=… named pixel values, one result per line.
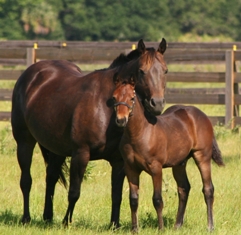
left=225, top=50, right=234, bottom=129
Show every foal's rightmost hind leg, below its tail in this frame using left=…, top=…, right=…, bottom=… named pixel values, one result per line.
left=194, top=151, right=214, bottom=231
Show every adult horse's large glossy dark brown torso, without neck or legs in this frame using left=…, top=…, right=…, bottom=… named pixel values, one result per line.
left=12, top=61, right=114, bottom=155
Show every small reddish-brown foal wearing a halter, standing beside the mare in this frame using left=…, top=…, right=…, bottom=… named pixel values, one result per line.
left=113, top=76, right=224, bottom=231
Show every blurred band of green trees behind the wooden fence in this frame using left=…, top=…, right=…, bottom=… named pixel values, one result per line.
left=0, top=0, right=241, bottom=41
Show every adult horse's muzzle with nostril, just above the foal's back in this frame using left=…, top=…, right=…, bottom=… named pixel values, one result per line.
left=144, top=98, right=166, bottom=116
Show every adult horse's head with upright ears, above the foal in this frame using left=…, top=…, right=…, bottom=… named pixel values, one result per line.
left=116, top=38, right=168, bottom=115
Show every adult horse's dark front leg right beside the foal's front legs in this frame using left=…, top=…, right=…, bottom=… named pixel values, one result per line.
left=110, top=160, right=125, bottom=228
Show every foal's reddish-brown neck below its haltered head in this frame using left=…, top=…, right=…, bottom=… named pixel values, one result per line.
left=125, top=97, right=150, bottom=140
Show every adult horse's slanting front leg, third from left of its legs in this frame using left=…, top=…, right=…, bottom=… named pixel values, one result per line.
left=63, top=150, right=90, bottom=226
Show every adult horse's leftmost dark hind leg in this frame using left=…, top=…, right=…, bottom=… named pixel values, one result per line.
left=17, top=136, right=36, bottom=224
